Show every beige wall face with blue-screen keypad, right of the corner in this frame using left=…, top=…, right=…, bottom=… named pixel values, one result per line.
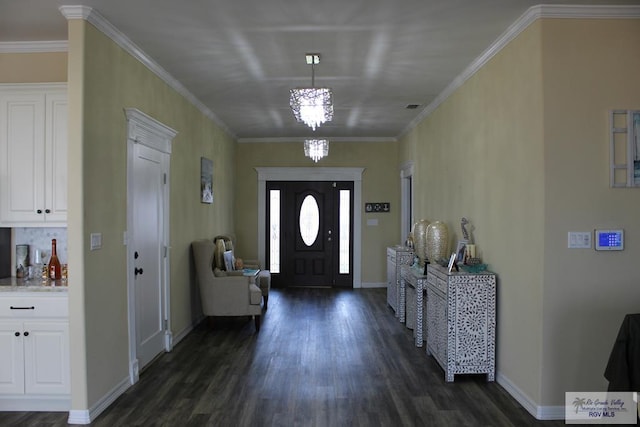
left=542, top=19, right=640, bottom=405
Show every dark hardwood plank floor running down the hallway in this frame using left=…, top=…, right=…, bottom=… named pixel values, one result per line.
left=0, top=288, right=564, bottom=427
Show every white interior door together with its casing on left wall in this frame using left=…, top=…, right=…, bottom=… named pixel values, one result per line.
left=125, top=109, right=176, bottom=384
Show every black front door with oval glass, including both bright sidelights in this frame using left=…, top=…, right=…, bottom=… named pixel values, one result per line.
left=267, top=181, right=353, bottom=287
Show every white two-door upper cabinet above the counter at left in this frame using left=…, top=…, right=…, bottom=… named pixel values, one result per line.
left=0, top=84, right=68, bottom=227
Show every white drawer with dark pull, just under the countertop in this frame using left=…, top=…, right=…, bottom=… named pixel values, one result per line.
left=0, top=295, right=69, bottom=318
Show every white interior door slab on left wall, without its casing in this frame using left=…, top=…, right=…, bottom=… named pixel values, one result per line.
left=132, top=144, right=165, bottom=369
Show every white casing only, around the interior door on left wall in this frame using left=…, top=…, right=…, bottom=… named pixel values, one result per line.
left=124, top=108, right=177, bottom=384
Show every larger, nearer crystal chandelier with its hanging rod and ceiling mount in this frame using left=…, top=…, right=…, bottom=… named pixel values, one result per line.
left=289, top=53, right=333, bottom=130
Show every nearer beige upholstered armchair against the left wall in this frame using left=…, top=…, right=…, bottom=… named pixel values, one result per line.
left=191, top=239, right=262, bottom=332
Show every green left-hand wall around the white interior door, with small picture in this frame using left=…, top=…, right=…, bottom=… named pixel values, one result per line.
left=68, top=21, right=235, bottom=409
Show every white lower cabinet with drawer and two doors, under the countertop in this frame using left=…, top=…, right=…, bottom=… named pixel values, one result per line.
left=0, top=293, right=71, bottom=411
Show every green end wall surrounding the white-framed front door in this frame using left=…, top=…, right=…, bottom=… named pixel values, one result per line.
left=235, top=141, right=400, bottom=286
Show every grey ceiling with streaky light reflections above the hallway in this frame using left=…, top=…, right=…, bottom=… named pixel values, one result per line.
left=0, top=0, right=640, bottom=141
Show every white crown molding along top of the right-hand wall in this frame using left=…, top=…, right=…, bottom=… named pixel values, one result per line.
left=398, top=4, right=640, bottom=139
